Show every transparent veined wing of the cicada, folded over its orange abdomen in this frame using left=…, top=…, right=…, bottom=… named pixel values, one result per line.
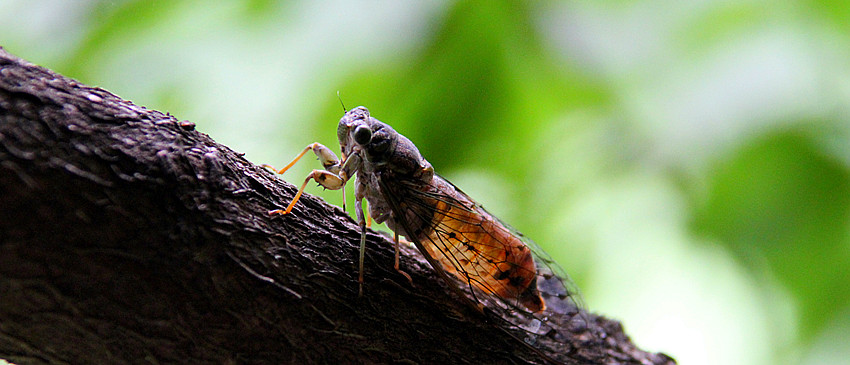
left=379, top=172, right=588, bottom=346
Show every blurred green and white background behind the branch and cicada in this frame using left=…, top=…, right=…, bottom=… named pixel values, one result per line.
left=0, top=0, right=850, bottom=364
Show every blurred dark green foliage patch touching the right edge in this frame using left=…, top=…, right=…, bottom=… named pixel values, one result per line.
left=694, top=131, right=850, bottom=341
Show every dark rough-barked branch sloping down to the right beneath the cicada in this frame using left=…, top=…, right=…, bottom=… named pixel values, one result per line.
left=0, top=48, right=673, bottom=364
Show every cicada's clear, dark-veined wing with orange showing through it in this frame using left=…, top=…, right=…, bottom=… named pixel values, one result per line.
left=380, top=172, right=577, bottom=313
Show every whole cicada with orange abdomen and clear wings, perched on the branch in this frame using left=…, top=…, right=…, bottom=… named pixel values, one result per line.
left=266, top=106, right=579, bottom=358
